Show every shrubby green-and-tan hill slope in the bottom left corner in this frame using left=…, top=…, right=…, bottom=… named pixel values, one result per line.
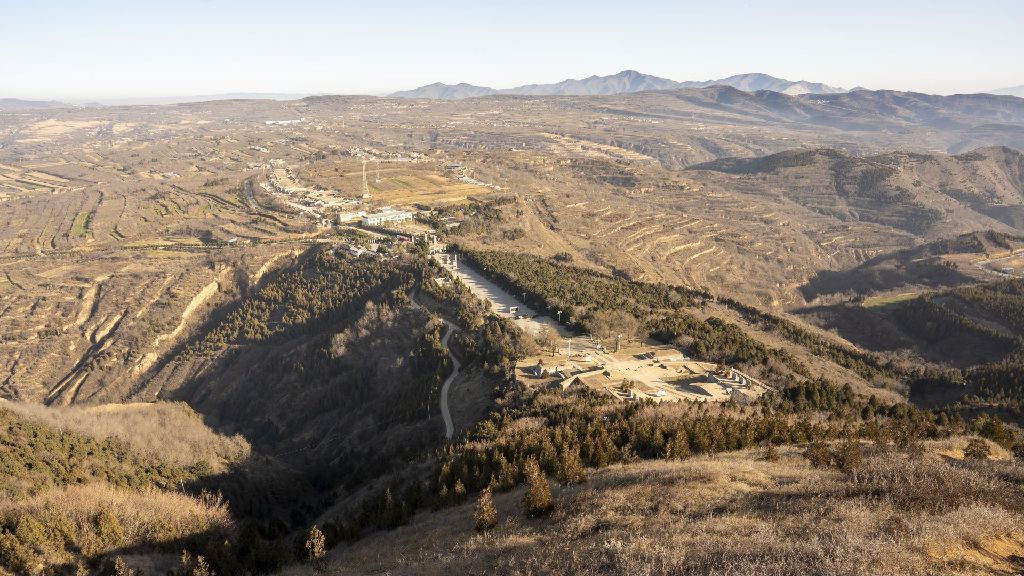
left=0, top=403, right=237, bottom=574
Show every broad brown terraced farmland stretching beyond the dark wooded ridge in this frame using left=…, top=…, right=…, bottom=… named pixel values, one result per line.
left=0, top=88, right=1024, bottom=403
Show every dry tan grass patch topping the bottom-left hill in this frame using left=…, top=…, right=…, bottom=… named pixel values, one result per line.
left=2, top=402, right=250, bottom=470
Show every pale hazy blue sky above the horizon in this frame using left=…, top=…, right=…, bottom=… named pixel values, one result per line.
left=0, top=0, right=1024, bottom=99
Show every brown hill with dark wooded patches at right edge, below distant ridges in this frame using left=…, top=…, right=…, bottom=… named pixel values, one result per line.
left=691, top=148, right=1024, bottom=239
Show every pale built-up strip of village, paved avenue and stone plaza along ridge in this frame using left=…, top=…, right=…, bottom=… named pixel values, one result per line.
left=253, top=150, right=769, bottom=402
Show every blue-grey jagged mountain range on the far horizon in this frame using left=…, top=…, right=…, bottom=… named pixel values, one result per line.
left=390, top=70, right=847, bottom=100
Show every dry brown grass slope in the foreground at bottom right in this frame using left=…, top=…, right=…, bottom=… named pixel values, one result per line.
left=280, top=449, right=1024, bottom=576
